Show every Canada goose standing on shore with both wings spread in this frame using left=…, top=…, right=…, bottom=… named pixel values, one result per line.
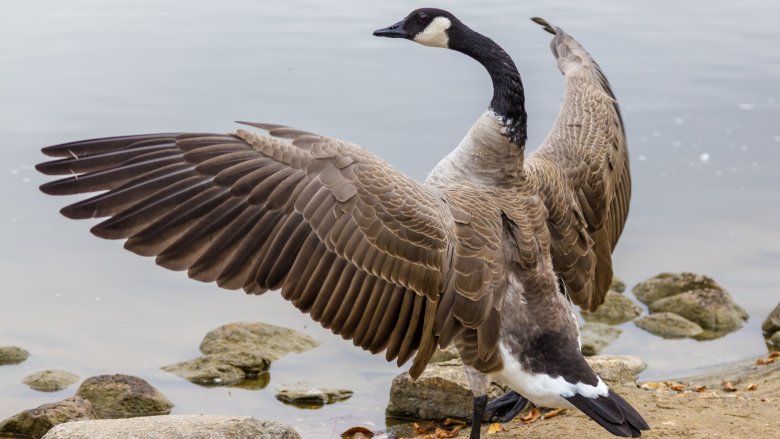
left=36, top=8, right=649, bottom=439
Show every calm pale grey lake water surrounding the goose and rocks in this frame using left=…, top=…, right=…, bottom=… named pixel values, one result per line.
left=0, top=0, right=780, bottom=437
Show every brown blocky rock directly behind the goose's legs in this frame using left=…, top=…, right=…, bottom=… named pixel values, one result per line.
left=386, top=360, right=504, bottom=420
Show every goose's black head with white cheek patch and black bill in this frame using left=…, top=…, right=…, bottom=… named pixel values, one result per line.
left=374, top=8, right=462, bottom=48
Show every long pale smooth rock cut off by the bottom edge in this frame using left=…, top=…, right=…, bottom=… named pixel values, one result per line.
left=39, top=415, right=301, bottom=439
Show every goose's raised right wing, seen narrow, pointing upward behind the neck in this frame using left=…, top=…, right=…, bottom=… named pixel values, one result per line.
left=526, top=18, right=631, bottom=310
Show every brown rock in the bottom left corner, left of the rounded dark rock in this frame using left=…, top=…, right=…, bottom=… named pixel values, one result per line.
left=0, top=396, right=96, bottom=439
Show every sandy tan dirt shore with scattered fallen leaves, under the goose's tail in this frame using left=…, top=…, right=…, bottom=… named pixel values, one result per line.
left=457, top=358, right=780, bottom=439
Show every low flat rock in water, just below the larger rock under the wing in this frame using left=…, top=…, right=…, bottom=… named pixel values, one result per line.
left=162, top=350, right=271, bottom=386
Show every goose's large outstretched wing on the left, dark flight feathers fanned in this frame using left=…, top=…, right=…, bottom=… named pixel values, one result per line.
left=37, top=124, right=501, bottom=375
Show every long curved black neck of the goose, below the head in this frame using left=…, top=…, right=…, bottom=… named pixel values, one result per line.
left=448, top=23, right=528, bottom=147
